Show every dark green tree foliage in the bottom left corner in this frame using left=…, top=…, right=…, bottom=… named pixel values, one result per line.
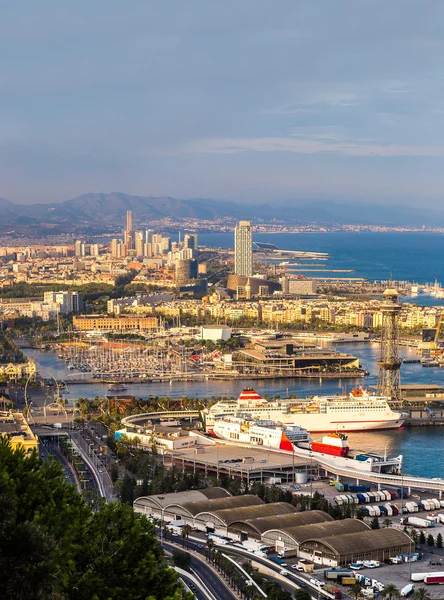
left=0, top=438, right=191, bottom=600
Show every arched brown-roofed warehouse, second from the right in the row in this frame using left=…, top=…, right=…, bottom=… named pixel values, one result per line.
left=262, top=511, right=369, bottom=558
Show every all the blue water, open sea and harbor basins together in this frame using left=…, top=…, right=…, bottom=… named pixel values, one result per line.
left=26, top=232, right=444, bottom=477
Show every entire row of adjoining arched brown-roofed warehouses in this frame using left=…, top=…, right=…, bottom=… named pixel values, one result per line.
left=134, top=488, right=413, bottom=567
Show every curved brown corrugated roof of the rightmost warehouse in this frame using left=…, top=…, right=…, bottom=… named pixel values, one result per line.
left=306, top=527, right=412, bottom=556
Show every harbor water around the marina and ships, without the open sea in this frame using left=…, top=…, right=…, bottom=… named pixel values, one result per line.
left=26, top=343, right=444, bottom=477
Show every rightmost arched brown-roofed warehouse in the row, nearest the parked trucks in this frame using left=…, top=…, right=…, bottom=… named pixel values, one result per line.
left=299, top=519, right=414, bottom=566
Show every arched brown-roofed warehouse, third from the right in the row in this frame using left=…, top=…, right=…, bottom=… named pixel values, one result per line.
left=228, top=502, right=333, bottom=545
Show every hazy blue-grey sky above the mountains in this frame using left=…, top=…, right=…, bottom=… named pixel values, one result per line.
left=0, top=0, right=444, bottom=208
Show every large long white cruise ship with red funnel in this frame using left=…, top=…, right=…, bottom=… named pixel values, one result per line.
left=201, top=388, right=406, bottom=433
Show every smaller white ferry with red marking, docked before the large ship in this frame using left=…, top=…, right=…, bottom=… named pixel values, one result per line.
left=212, top=417, right=310, bottom=452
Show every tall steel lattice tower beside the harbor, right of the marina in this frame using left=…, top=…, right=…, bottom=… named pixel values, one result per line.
left=378, top=287, right=401, bottom=401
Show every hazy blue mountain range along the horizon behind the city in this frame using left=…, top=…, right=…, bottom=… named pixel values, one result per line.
left=0, top=192, right=444, bottom=231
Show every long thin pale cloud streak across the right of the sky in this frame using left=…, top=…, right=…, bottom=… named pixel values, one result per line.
left=182, top=133, right=444, bottom=158
